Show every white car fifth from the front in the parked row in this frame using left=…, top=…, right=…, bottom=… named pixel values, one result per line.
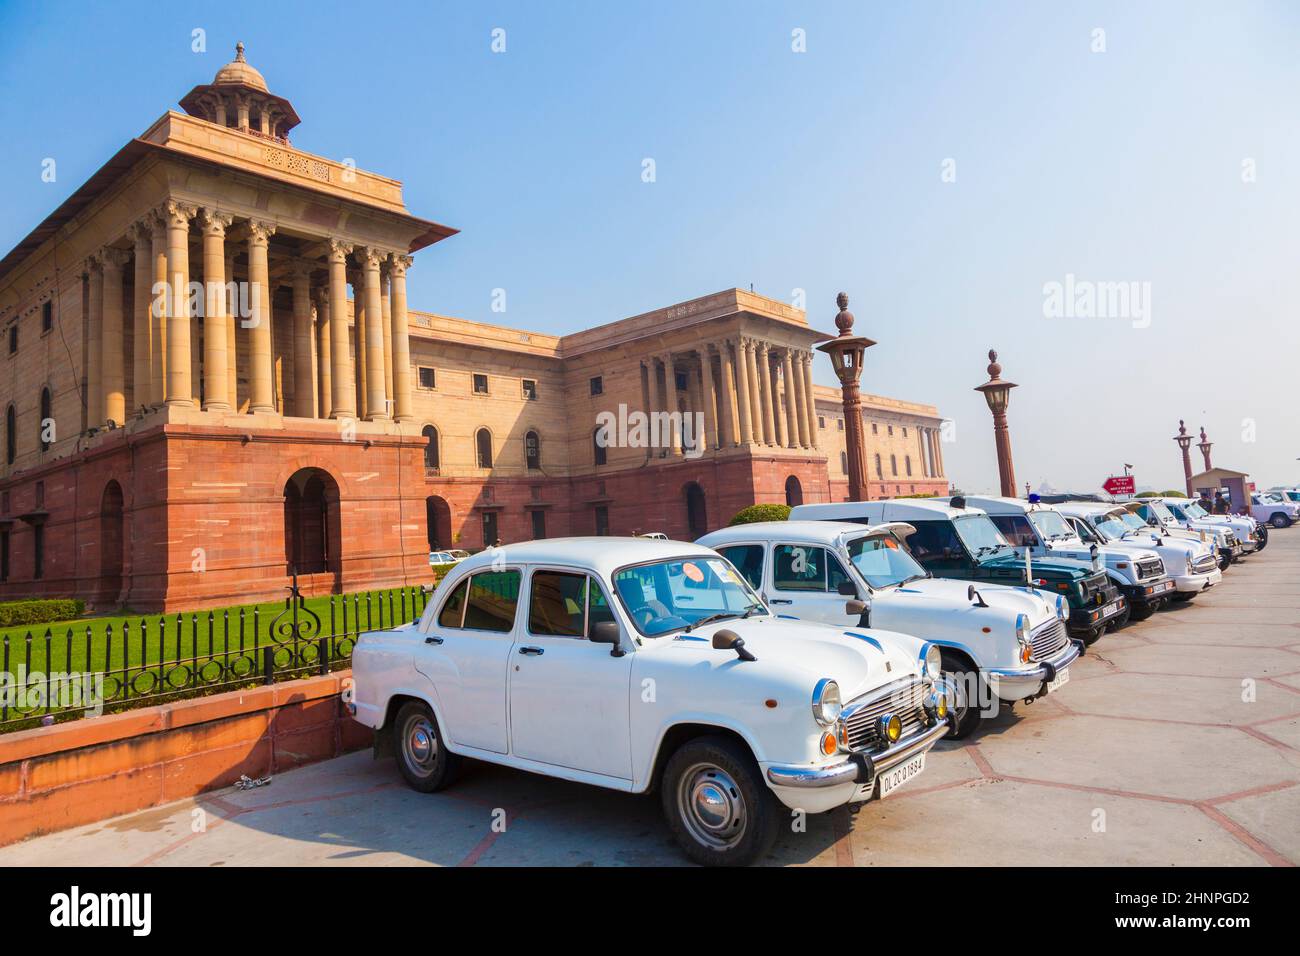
left=1056, top=501, right=1223, bottom=601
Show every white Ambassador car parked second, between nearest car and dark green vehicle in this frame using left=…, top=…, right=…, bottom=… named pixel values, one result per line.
left=697, top=520, right=1080, bottom=737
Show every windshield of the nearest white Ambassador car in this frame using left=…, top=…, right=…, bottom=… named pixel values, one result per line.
left=614, top=555, right=767, bottom=637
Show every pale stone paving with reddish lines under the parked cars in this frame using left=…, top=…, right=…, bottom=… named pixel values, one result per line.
left=0, top=527, right=1300, bottom=866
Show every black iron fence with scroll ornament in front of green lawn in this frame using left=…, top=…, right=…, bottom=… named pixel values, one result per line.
left=0, top=574, right=433, bottom=734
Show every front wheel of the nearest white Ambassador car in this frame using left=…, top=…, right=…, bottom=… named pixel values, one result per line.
left=660, top=736, right=783, bottom=866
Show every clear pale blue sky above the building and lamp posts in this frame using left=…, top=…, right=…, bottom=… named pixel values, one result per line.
left=0, top=0, right=1300, bottom=490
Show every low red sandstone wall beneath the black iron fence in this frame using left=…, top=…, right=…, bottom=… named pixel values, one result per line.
left=0, top=671, right=372, bottom=845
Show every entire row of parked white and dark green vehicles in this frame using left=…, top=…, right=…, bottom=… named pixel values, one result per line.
left=348, top=497, right=1260, bottom=865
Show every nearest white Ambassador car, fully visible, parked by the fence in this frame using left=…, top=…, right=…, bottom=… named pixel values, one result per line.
left=350, top=537, right=948, bottom=865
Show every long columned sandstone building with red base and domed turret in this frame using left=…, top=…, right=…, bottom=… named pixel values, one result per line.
left=0, top=48, right=946, bottom=610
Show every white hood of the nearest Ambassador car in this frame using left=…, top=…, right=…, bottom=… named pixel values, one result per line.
left=657, top=617, right=924, bottom=701
